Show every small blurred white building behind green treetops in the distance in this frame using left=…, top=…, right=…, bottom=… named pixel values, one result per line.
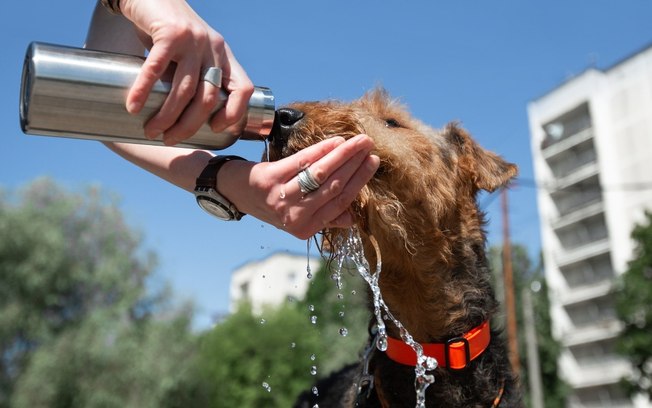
left=229, top=252, right=321, bottom=314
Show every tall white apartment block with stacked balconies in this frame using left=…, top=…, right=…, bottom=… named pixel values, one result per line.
left=528, top=46, right=652, bottom=408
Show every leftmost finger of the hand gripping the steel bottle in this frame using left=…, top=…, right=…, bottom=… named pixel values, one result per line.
left=126, top=44, right=171, bottom=115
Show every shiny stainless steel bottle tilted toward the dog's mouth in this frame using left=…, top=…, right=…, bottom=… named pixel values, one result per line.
left=20, top=42, right=275, bottom=150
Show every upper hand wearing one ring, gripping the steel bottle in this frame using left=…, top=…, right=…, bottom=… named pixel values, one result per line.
left=120, top=0, right=254, bottom=145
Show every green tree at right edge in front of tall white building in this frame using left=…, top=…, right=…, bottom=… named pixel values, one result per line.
left=616, top=212, right=652, bottom=400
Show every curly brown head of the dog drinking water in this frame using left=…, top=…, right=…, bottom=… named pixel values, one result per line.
left=269, top=90, right=516, bottom=261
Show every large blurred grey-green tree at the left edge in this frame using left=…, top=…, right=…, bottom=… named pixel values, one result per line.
left=0, top=179, right=204, bottom=407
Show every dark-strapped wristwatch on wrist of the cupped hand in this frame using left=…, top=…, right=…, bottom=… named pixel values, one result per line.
left=194, top=155, right=246, bottom=221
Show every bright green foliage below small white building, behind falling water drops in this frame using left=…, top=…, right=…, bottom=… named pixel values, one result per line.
left=200, top=263, right=368, bottom=408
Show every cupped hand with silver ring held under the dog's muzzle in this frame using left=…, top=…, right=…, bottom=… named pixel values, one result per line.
left=222, top=135, right=380, bottom=239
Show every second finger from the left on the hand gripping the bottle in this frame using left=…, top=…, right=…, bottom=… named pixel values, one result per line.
left=145, top=58, right=200, bottom=138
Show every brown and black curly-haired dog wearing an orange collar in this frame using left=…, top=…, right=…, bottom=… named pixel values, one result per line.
left=268, top=89, right=522, bottom=408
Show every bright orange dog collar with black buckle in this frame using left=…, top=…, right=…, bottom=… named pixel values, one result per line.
left=385, top=321, right=491, bottom=370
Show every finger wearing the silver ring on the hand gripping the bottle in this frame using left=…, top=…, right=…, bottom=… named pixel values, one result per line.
left=164, top=67, right=224, bottom=144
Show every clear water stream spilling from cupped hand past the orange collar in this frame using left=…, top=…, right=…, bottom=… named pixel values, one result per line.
left=334, top=227, right=438, bottom=408
